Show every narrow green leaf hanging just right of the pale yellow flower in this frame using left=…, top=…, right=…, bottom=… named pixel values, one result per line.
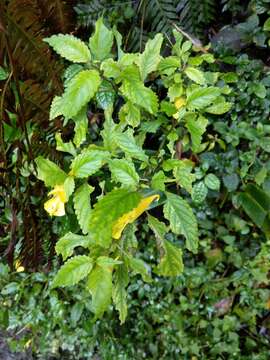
left=73, top=183, right=94, bottom=234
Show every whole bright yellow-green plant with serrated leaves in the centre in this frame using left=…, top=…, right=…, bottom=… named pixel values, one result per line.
left=36, top=19, right=230, bottom=322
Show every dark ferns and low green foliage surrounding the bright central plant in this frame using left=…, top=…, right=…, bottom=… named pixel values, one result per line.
left=0, top=0, right=270, bottom=360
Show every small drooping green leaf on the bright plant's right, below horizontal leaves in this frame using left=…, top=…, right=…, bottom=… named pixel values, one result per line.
left=186, top=116, right=208, bottom=152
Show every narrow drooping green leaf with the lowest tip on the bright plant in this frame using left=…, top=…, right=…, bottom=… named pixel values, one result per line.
left=112, top=264, right=129, bottom=324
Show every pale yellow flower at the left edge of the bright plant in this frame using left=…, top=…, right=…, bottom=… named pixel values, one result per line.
left=44, top=185, right=68, bottom=216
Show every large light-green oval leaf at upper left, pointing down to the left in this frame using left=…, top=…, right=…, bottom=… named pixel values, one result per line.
left=57, top=70, right=100, bottom=119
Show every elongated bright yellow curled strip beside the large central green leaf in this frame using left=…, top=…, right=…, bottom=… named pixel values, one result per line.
left=112, top=195, right=159, bottom=239
